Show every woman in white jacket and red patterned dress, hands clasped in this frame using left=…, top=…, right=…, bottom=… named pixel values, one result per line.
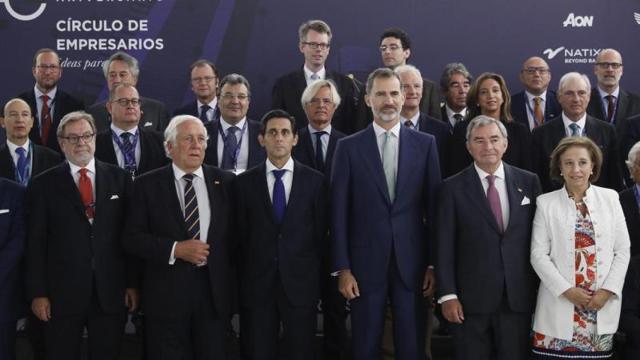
left=531, top=137, right=630, bottom=359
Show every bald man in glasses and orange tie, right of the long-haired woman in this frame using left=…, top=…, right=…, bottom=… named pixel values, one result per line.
left=511, top=56, right=562, bottom=131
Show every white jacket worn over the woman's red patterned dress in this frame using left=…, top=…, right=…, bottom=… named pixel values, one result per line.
left=531, top=185, right=630, bottom=340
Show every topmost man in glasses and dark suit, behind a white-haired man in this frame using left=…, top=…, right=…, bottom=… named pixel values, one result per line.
left=271, top=20, right=361, bottom=134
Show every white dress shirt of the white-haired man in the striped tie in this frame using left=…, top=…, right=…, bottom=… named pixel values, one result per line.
left=169, top=164, right=211, bottom=265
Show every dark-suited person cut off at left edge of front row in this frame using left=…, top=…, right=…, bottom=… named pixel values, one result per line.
left=0, top=178, right=27, bottom=359
